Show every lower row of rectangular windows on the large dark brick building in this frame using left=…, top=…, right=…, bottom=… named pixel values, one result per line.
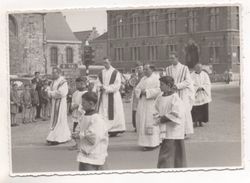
left=114, top=45, right=240, bottom=62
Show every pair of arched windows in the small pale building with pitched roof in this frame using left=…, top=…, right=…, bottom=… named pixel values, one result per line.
left=50, top=47, right=74, bottom=66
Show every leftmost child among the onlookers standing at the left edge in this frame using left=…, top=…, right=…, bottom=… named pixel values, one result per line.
left=10, top=83, right=20, bottom=126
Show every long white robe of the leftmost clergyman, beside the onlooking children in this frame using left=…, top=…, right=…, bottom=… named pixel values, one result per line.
left=47, top=77, right=71, bottom=143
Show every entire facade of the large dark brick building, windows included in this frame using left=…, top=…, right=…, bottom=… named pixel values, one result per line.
left=107, top=6, right=240, bottom=73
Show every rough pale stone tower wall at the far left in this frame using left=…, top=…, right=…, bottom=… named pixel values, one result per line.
left=9, top=13, right=45, bottom=74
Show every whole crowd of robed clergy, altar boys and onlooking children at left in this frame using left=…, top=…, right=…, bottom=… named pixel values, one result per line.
left=10, top=53, right=211, bottom=171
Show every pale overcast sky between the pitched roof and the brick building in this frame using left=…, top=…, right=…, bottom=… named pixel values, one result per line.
left=63, top=9, right=107, bottom=34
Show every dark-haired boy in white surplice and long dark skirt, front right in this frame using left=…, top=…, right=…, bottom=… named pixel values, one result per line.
left=154, top=76, right=186, bottom=168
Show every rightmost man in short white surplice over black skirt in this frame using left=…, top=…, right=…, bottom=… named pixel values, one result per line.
left=191, top=63, right=212, bottom=127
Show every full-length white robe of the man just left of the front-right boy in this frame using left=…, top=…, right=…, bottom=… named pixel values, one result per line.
left=135, top=73, right=161, bottom=147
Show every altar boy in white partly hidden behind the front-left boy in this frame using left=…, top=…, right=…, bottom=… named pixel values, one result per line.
left=70, top=77, right=87, bottom=150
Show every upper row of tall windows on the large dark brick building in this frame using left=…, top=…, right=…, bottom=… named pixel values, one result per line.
left=112, top=8, right=239, bottom=38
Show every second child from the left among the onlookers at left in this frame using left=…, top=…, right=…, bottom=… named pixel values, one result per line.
left=20, top=84, right=32, bottom=124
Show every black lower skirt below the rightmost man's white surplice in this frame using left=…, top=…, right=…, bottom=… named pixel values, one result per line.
left=191, top=103, right=208, bottom=123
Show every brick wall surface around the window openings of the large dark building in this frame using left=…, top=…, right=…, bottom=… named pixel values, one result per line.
left=107, top=7, right=240, bottom=73
